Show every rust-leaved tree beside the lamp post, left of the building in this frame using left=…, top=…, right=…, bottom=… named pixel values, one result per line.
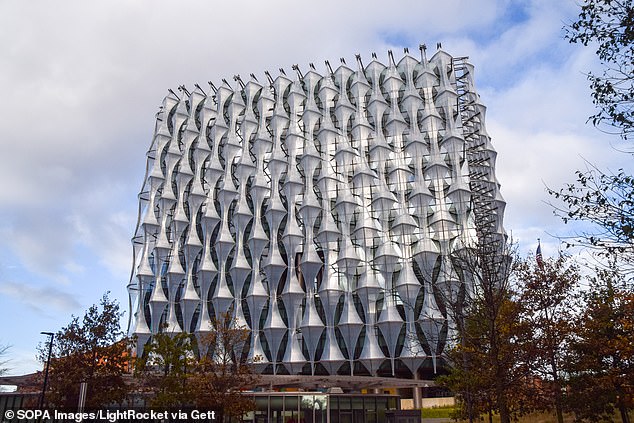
left=38, top=293, right=130, bottom=408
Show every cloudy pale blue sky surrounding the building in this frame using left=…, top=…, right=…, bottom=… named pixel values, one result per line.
left=0, top=0, right=632, bottom=374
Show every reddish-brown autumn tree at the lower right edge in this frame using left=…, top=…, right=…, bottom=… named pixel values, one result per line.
left=565, top=269, right=634, bottom=423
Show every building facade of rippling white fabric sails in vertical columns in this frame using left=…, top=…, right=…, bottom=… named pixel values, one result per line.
left=128, top=50, right=504, bottom=377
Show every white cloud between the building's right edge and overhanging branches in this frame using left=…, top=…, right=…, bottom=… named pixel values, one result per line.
left=484, top=44, right=629, bottom=237
